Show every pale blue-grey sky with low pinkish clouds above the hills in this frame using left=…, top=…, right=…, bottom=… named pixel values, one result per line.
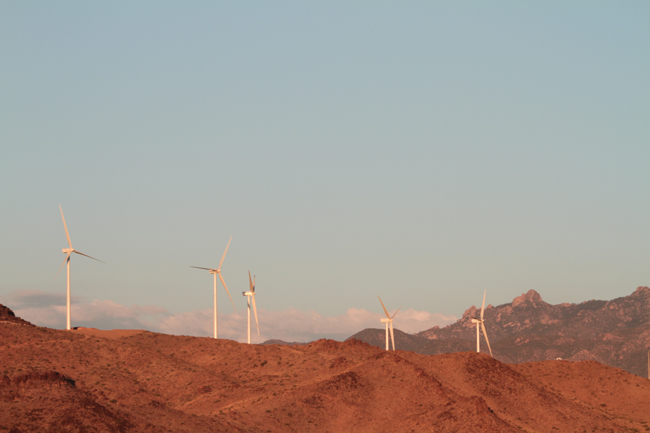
left=0, top=1, right=650, bottom=342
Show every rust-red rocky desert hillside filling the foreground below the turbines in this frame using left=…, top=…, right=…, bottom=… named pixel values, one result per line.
left=0, top=310, right=650, bottom=433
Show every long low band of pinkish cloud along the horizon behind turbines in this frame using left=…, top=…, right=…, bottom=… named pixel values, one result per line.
left=0, top=290, right=457, bottom=343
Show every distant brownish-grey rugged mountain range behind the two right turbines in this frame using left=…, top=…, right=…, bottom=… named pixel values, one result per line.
left=350, top=287, right=650, bottom=377
